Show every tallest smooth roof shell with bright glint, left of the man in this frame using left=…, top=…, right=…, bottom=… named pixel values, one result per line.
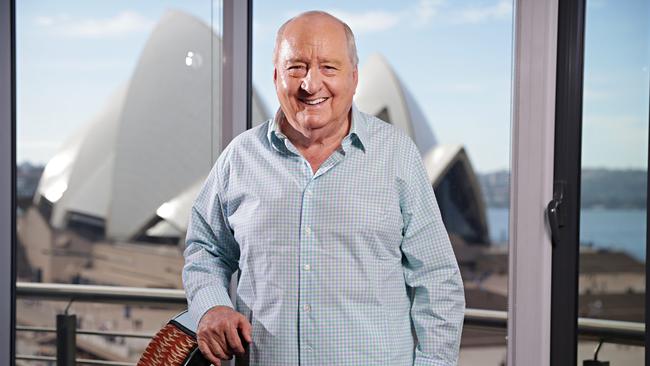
left=106, top=12, right=221, bottom=238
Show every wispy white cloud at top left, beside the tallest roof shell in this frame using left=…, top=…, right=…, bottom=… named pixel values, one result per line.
left=34, top=11, right=155, bottom=38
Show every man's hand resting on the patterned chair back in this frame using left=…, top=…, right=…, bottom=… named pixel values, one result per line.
left=196, top=306, right=253, bottom=366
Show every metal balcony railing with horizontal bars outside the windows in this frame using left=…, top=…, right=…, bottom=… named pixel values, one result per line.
left=16, top=282, right=645, bottom=366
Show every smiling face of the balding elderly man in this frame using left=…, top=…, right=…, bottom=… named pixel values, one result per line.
left=273, top=17, right=358, bottom=134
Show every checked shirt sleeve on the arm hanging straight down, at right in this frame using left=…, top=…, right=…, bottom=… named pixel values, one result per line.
left=400, top=141, right=465, bottom=366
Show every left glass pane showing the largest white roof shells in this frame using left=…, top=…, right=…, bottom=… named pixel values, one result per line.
left=16, top=0, right=222, bottom=362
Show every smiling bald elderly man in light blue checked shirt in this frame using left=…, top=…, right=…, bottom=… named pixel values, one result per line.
left=183, top=12, right=464, bottom=366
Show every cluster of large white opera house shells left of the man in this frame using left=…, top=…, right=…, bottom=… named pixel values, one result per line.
left=35, top=11, right=233, bottom=239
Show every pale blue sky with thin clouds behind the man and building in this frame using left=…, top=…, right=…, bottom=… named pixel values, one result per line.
left=17, top=0, right=650, bottom=172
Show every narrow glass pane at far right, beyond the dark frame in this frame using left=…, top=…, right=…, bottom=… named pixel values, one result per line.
left=578, top=0, right=650, bottom=365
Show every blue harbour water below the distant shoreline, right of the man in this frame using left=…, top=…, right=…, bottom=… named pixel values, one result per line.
left=488, top=208, right=646, bottom=262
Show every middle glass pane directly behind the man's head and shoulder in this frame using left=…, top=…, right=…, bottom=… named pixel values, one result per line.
left=253, top=0, right=513, bottom=365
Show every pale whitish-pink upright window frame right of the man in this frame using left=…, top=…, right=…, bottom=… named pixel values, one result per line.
left=507, top=0, right=558, bottom=366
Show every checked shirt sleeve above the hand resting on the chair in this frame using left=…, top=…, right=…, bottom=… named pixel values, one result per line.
left=183, top=163, right=239, bottom=324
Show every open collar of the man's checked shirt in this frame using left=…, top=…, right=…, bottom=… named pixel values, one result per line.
left=266, top=103, right=368, bottom=155
